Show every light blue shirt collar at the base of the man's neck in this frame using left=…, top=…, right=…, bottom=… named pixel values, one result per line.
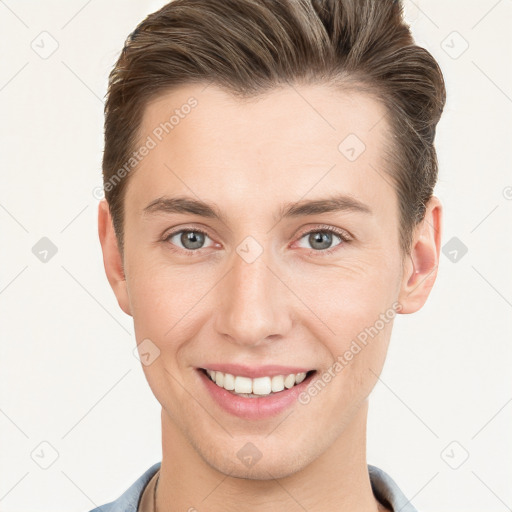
left=90, top=462, right=417, bottom=512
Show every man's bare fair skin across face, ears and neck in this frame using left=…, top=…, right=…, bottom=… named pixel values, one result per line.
left=99, top=84, right=442, bottom=512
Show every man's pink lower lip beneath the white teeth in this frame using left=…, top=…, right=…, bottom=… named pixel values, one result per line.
left=197, top=369, right=315, bottom=420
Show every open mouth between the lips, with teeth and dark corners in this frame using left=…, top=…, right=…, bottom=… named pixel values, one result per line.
left=198, top=368, right=316, bottom=399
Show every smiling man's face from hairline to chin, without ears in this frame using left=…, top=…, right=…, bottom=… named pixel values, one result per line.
left=110, top=85, right=410, bottom=478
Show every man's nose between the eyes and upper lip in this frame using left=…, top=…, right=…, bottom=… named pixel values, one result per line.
left=215, top=244, right=293, bottom=346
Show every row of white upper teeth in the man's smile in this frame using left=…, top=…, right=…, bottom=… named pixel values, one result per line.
left=202, top=370, right=306, bottom=397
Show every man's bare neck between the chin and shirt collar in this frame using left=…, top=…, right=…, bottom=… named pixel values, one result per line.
left=156, top=401, right=385, bottom=512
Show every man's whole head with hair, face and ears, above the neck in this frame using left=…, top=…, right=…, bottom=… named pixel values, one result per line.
left=99, top=0, right=445, bottom=478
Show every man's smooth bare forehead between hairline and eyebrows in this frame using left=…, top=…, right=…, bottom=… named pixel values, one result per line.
left=126, top=84, right=393, bottom=218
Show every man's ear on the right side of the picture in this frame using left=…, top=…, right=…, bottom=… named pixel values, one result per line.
left=398, top=196, right=442, bottom=314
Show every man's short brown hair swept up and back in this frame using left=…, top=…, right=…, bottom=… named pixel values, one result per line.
left=103, top=0, right=446, bottom=254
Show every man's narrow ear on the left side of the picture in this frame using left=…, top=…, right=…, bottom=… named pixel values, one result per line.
left=98, top=199, right=131, bottom=316
